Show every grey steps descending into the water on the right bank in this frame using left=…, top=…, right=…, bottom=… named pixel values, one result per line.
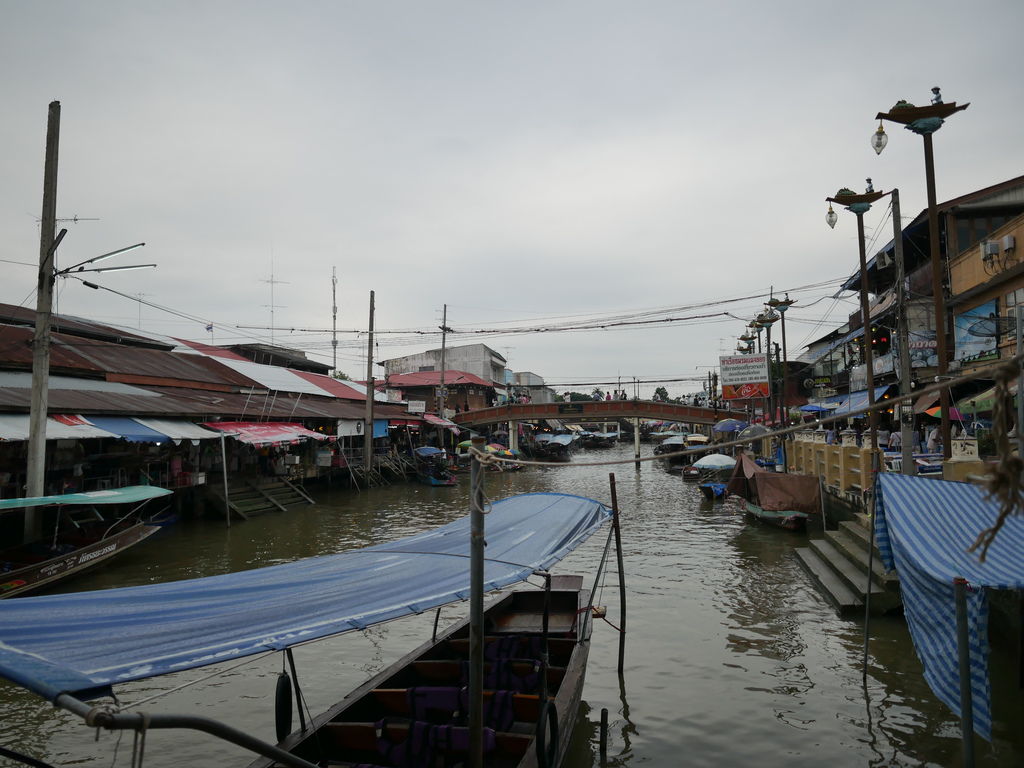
left=796, top=513, right=902, bottom=615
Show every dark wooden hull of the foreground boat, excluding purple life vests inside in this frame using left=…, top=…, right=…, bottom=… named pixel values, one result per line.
left=250, top=577, right=591, bottom=768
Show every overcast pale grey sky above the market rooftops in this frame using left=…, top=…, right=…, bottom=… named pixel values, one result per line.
left=0, top=0, right=1024, bottom=395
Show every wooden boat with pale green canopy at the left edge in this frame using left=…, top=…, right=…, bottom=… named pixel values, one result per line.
left=0, top=485, right=171, bottom=598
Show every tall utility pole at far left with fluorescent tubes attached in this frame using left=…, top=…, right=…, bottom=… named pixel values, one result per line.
left=25, top=101, right=60, bottom=539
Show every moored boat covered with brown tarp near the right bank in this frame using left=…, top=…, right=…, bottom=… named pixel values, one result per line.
left=728, top=454, right=821, bottom=530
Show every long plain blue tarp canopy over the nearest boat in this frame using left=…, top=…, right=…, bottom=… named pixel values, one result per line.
left=0, top=494, right=611, bottom=700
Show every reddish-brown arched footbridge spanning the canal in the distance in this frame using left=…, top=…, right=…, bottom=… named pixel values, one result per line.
left=452, top=400, right=746, bottom=427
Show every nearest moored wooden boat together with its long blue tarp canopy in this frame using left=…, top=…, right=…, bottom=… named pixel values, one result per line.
left=0, top=494, right=612, bottom=768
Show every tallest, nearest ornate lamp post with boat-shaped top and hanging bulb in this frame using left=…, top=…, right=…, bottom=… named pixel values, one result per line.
left=871, top=88, right=970, bottom=459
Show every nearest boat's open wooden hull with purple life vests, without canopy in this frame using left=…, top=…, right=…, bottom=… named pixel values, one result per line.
left=249, top=575, right=591, bottom=768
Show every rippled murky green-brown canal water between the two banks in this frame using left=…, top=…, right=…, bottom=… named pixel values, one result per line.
left=0, top=445, right=1024, bottom=768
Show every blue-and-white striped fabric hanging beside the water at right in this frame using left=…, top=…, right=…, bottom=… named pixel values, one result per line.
left=874, top=472, right=1024, bottom=740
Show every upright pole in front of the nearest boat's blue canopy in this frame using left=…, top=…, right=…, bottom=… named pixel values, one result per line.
left=469, top=436, right=485, bottom=768
